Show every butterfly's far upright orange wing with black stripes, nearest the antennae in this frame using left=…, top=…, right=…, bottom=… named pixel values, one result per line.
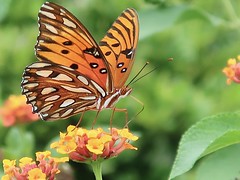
left=99, top=8, right=139, bottom=88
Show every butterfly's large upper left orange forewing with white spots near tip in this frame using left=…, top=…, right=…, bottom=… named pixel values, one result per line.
left=35, top=2, right=112, bottom=91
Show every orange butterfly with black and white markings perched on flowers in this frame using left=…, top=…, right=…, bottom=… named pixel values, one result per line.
left=21, top=2, right=139, bottom=120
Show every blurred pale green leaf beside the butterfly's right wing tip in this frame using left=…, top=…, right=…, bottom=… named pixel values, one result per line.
left=139, top=5, right=224, bottom=39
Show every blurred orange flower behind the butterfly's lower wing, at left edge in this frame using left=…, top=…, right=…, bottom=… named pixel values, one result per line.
left=0, top=95, right=39, bottom=127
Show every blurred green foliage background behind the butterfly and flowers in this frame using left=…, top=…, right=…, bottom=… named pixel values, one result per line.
left=0, top=0, right=240, bottom=180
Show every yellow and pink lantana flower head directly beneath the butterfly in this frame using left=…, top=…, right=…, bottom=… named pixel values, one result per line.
left=51, top=125, right=138, bottom=162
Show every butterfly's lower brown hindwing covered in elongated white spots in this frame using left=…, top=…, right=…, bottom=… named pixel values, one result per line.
left=21, top=62, right=106, bottom=120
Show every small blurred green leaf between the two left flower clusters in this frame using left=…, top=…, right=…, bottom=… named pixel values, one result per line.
left=3, top=126, right=35, bottom=159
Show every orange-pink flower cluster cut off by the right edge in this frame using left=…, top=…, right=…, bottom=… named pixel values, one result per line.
left=222, top=56, right=240, bottom=84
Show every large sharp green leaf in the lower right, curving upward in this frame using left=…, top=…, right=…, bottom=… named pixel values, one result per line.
left=169, top=112, right=240, bottom=179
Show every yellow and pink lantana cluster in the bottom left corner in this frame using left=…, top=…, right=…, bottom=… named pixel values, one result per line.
left=2, top=151, right=69, bottom=180
